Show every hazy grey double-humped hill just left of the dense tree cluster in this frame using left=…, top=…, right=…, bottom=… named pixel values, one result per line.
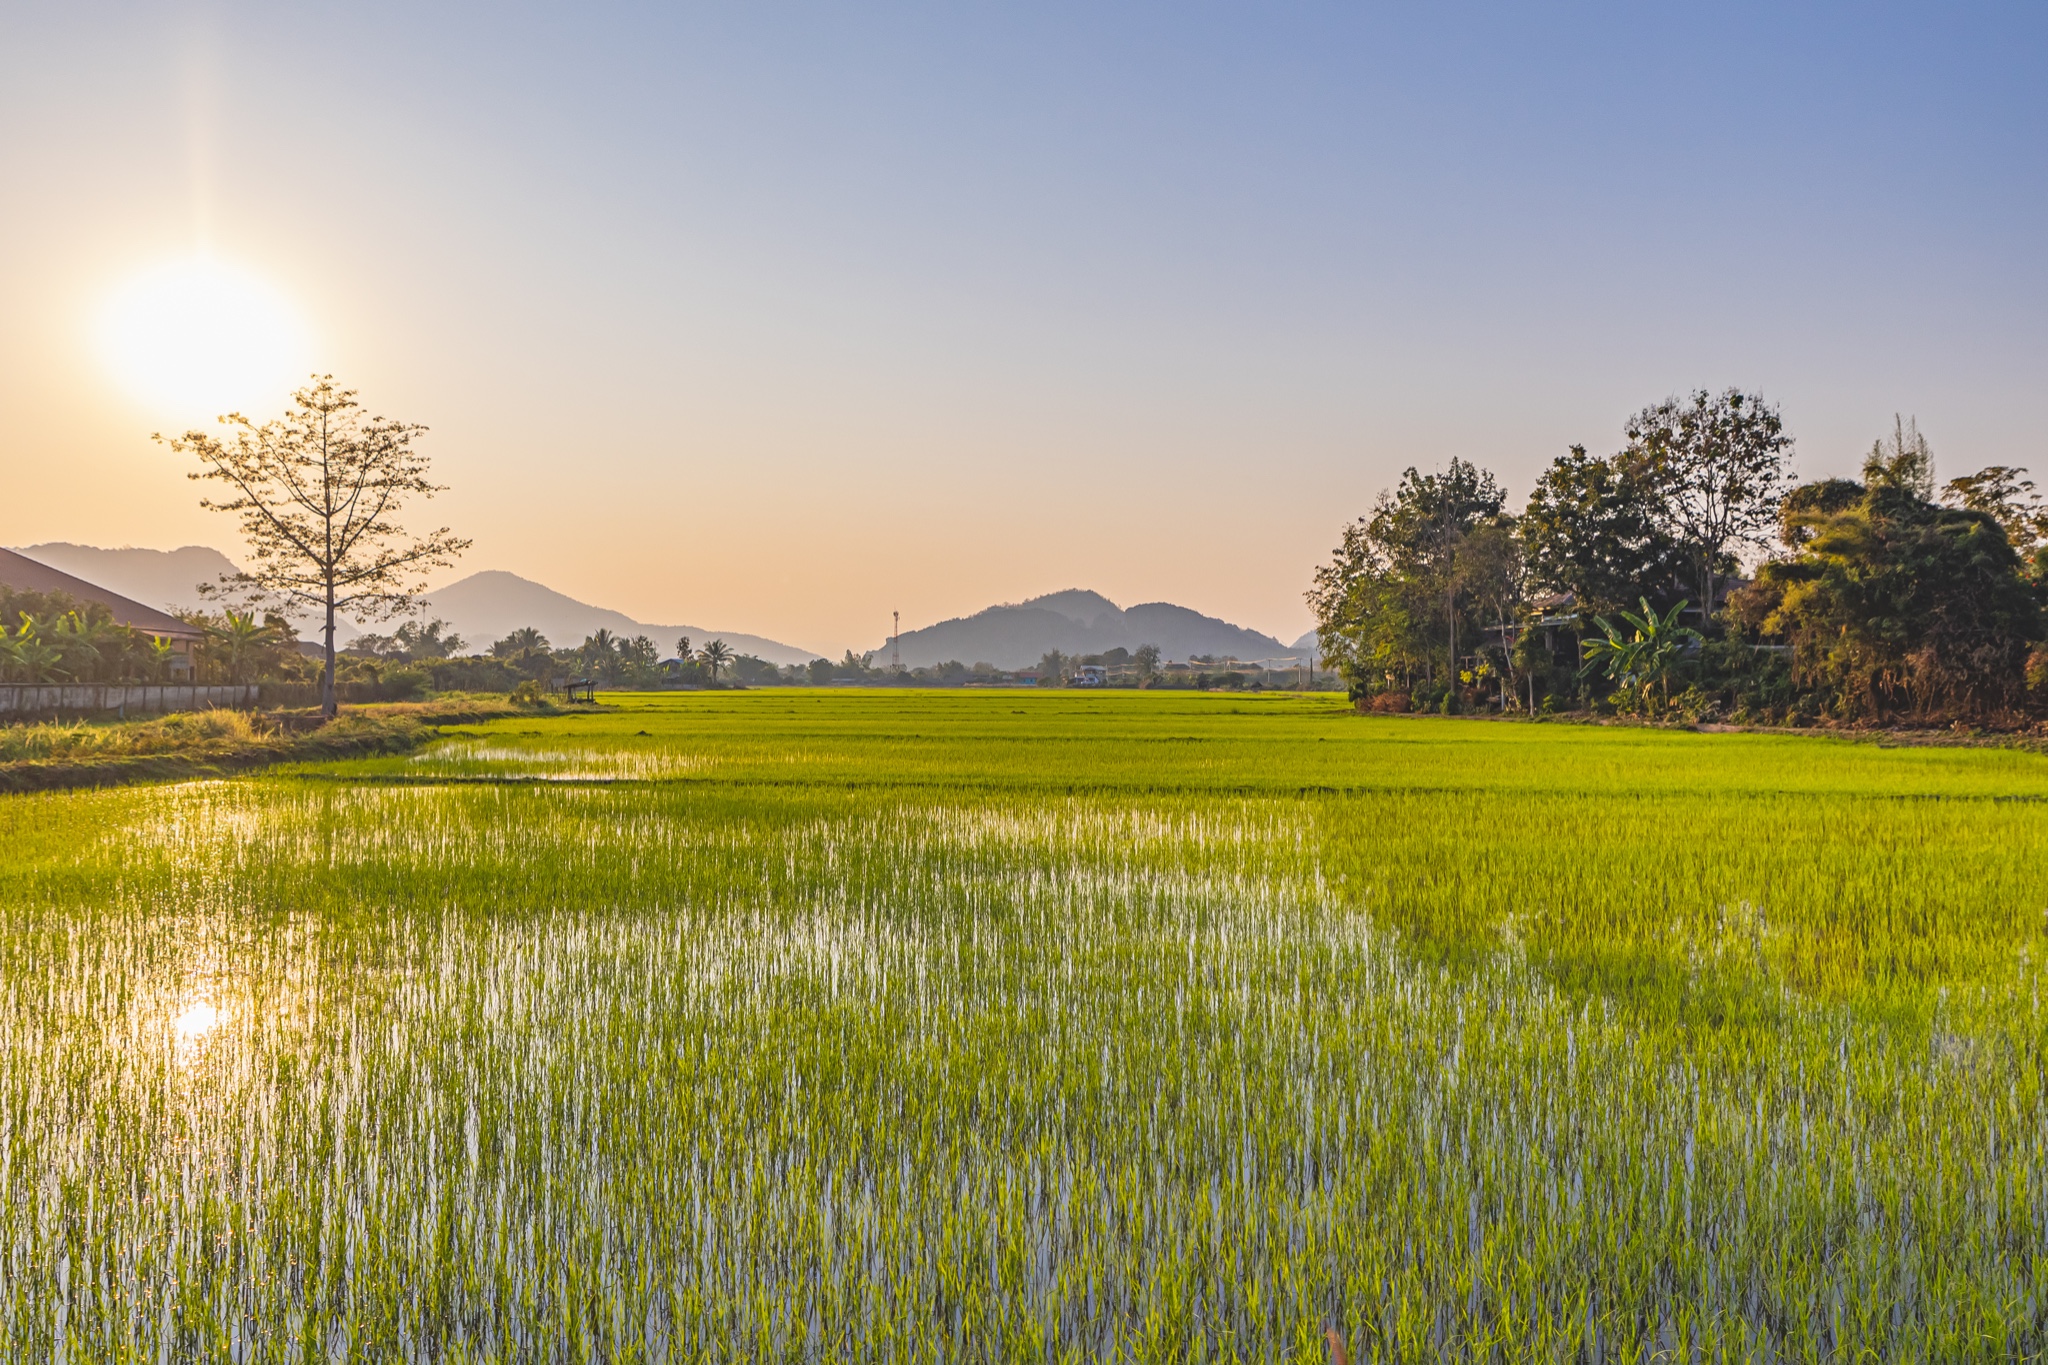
left=874, top=587, right=1292, bottom=669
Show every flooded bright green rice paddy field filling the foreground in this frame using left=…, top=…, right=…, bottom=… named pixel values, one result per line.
left=0, top=690, right=2048, bottom=1365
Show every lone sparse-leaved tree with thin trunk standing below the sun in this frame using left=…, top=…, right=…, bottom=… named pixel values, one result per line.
left=156, top=375, right=469, bottom=718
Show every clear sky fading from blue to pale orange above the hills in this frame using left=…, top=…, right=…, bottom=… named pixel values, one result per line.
left=0, top=2, right=2048, bottom=657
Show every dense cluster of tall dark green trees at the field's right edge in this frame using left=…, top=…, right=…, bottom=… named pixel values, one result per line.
left=1307, top=389, right=2048, bottom=724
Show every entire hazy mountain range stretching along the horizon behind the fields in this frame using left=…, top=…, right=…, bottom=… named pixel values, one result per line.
left=20, top=540, right=1315, bottom=669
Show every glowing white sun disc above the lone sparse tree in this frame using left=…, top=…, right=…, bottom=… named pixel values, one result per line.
left=100, top=256, right=307, bottom=422
